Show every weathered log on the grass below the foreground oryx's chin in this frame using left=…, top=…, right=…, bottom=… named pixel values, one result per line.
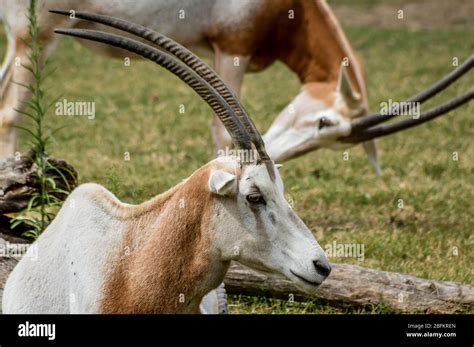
left=224, top=264, right=474, bottom=313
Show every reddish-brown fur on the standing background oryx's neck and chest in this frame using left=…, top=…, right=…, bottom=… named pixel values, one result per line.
left=209, top=0, right=365, bottom=102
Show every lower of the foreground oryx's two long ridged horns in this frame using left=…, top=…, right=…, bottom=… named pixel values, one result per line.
left=54, top=29, right=252, bottom=154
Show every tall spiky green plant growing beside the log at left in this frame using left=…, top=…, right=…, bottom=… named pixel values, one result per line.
left=11, top=0, right=74, bottom=239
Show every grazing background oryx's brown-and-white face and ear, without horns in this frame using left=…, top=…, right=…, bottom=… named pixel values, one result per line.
left=263, top=65, right=367, bottom=161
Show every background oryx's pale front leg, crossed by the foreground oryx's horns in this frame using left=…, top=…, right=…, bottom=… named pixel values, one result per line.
left=211, top=48, right=250, bottom=153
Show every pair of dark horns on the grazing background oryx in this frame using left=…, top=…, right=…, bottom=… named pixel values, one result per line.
left=339, top=55, right=474, bottom=143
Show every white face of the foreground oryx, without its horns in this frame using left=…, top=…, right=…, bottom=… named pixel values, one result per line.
left=209, top=157, right=331, bottom=291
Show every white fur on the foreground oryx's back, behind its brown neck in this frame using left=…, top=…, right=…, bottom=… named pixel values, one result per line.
left=3, top=184, right=122, bottom=313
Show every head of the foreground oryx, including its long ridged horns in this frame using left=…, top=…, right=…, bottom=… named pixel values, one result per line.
left=54, top=11, right=331, bottom=291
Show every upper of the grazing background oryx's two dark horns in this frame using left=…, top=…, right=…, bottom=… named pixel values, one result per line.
left=351, top=55, right=474, bottom=133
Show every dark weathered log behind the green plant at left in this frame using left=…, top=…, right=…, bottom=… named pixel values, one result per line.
left=0, top=151, right=77, bottom=214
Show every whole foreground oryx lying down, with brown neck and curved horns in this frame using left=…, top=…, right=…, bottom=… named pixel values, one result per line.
left=3, top=18, right=331, bottom=313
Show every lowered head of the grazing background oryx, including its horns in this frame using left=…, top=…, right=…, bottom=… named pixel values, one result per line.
left=264, top=55, right=474, bottom=165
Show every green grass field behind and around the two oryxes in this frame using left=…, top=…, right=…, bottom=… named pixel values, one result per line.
left=2, top=0, right=474, bottom=313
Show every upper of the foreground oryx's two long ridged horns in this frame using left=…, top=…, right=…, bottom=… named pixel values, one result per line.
left=49, top=10, right=270, bottom=160
